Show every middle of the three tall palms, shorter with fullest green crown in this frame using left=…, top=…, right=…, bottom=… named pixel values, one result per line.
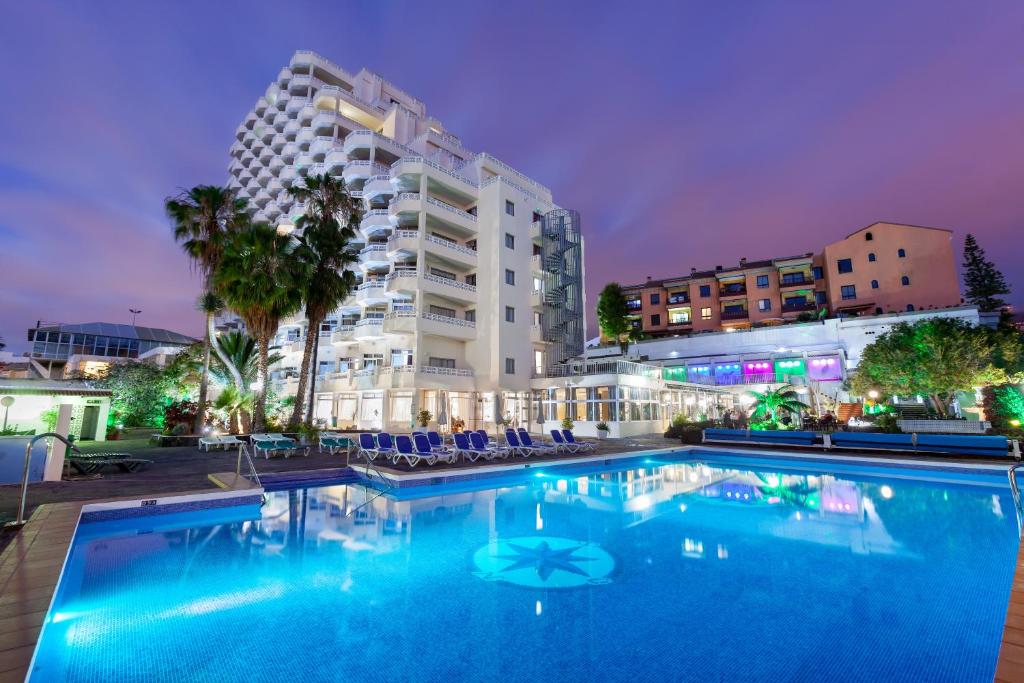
left=214, top=225, right=308, bottom=431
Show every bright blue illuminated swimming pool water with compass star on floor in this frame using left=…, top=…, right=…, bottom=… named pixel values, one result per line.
left=32, top=456, right=1018, bottom=682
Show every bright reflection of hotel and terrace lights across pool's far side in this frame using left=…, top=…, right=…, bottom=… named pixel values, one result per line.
left=253, top=463, right=902, bottom=559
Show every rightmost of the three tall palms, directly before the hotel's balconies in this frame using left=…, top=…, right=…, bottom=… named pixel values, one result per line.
left=290, top=173, right=359, bottom=425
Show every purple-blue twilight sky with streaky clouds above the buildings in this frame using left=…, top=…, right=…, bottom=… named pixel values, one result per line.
left=0, top=0, right=1024, bottom=351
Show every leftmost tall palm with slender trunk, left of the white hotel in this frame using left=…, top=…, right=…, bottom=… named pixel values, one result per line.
left=164, top=185, right=249, bottom=433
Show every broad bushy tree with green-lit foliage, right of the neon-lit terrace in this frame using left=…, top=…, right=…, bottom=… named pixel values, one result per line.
left=851, top=317, right=1021, bottom=416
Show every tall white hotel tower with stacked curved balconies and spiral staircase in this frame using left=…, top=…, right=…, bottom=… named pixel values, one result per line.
left=229, top=51, right=585, bottom=430
